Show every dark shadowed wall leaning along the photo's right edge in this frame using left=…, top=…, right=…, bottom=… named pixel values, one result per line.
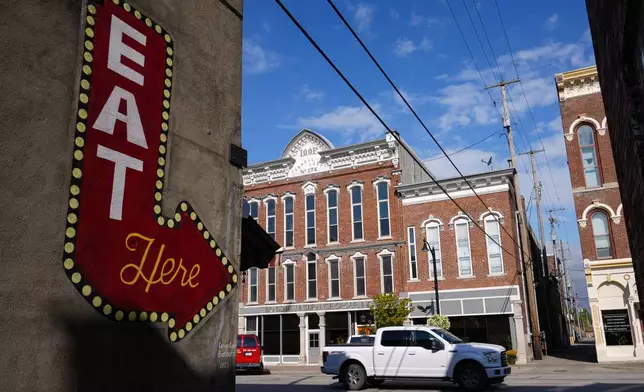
left=586, top=0, right=644, bottom=356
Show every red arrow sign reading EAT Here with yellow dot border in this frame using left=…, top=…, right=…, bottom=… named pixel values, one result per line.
left=63, top=0, right=237, bottom=342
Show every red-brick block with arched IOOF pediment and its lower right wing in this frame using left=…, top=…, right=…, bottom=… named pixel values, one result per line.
left=239, top=130, right=530, bottom=364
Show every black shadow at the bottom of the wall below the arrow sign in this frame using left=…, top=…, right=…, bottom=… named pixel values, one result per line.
left=64, top=318, right=220, bottom=392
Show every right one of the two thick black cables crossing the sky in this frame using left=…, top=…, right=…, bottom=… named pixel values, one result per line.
left=327, top=0, right=531, bottom=268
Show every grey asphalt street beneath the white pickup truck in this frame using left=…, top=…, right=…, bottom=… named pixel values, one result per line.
left=237, top=371, right=644, bottom=392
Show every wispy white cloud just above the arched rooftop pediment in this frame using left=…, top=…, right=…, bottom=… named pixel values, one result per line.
left=297, top=104, right=387, bottom=140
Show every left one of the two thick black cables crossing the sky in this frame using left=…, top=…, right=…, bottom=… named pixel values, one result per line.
left=275, top=0, right=531, bottom=268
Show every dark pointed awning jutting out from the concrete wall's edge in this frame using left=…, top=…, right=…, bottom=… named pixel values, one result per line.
left=239, top=202, right=281, bottom=272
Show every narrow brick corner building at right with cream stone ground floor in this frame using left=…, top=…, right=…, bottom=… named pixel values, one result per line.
left=555, top=66, right=644, bottom=362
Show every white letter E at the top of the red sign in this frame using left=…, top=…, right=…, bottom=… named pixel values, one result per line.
left=107, top=15, right=147, bottom=86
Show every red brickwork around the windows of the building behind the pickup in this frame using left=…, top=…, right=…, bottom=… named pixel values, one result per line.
left=240, top=146, right=521, bottom=304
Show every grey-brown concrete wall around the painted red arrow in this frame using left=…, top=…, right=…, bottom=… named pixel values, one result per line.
left=0, top=0, right=242, bottom=391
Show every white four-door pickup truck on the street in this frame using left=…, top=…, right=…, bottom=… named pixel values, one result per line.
left=321, top=326, right=511, bottom=391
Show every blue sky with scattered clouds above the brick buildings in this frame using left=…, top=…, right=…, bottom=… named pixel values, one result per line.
left=242, top=0, right=594, bottom=306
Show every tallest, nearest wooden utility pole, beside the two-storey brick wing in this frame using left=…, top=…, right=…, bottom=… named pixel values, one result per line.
left=485, top=79, right=543, bottom=360
